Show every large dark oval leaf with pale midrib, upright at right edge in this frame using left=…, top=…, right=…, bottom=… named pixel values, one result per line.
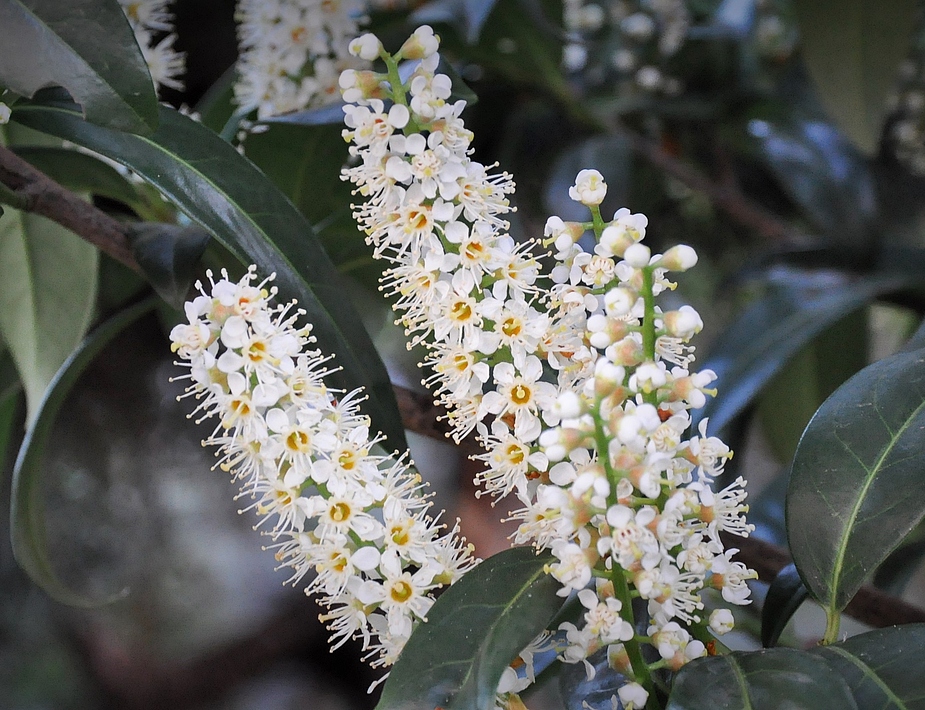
left=787, top=350, right=925, bottom=617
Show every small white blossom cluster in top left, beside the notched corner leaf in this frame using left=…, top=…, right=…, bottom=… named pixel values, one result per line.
left=119, top=0, right=186, bottom=91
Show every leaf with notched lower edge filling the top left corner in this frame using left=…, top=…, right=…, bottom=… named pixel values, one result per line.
left=0, top=0, right=158, bottom=134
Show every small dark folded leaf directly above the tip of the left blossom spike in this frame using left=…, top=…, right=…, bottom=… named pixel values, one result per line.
left=129, top=222, right=210, bottom=310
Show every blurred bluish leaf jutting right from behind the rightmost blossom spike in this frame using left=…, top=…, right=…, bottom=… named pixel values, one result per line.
left=694, top=272, right=905, bottom=431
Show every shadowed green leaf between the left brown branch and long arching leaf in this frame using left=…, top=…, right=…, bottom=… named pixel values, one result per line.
left=13, top=146, right=142, bottom=209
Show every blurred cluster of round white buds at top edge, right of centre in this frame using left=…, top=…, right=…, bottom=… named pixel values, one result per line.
left=563, top=0, right=691, bottom=95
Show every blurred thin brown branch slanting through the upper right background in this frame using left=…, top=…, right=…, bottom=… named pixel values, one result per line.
left=605, top=118, right=806, bottom=244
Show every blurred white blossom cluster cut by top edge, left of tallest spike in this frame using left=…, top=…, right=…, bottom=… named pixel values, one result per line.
left=234, top=0, right=364, bottom=118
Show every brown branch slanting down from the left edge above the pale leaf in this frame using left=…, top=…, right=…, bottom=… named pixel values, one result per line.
left=0, top=146, right=140, bottom=271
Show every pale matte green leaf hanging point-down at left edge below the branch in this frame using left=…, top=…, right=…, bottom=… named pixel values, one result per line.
left=0, top=200, right=99, bottom=419
